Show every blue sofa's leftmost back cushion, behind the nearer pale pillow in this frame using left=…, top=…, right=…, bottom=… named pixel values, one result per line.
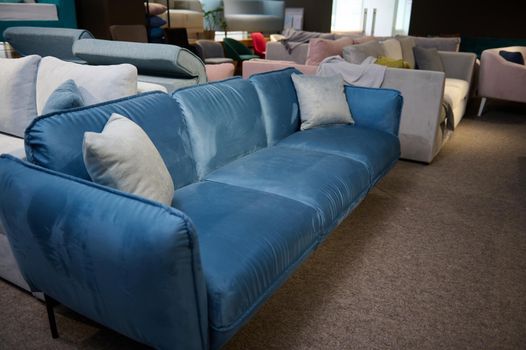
left=26, top=92, right=196, bottom=188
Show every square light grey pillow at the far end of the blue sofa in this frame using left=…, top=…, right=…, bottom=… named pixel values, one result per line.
left=292, top=74, right=354, bottom=130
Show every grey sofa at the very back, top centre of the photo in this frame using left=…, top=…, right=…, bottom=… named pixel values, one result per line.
left=224, top=0, right=285, bottom=33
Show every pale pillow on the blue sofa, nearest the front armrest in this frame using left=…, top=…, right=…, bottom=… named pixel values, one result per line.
left=82, top=113, right=174, bottom=205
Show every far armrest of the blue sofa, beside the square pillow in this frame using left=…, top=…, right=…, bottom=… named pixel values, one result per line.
left=345, top=85, right=404, bottom=136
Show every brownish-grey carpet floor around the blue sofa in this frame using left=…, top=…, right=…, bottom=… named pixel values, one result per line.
left=0, top=100, right=526, bottom=350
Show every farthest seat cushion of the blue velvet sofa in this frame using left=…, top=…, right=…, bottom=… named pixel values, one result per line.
left=278, top=125, right=400, bottom=185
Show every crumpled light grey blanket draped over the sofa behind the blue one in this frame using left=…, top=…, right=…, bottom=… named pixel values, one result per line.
left=316, top=56, right=387, bottom=88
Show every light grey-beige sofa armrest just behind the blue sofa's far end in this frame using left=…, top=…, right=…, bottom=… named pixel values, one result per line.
left=382, top=68, right=445, bottom=163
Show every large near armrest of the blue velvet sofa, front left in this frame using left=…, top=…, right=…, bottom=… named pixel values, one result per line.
left=0, top=155, right=208, bottom=349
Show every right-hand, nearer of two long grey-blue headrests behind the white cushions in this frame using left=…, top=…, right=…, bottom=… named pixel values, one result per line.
left=73, top=39, right=206, bottom=82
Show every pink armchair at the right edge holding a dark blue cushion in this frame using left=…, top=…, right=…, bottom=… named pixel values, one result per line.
left=478, top=46, right=526, bottom=117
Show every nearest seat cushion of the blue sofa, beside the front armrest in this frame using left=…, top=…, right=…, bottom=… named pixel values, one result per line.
left=173, top=181, right=320, bottom=348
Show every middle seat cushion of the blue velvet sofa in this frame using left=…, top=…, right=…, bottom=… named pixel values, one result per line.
left=207, top=147, right=370, bottom=234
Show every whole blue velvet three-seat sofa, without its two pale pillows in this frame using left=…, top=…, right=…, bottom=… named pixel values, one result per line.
left=0, top=69, right=402, bottom=349
